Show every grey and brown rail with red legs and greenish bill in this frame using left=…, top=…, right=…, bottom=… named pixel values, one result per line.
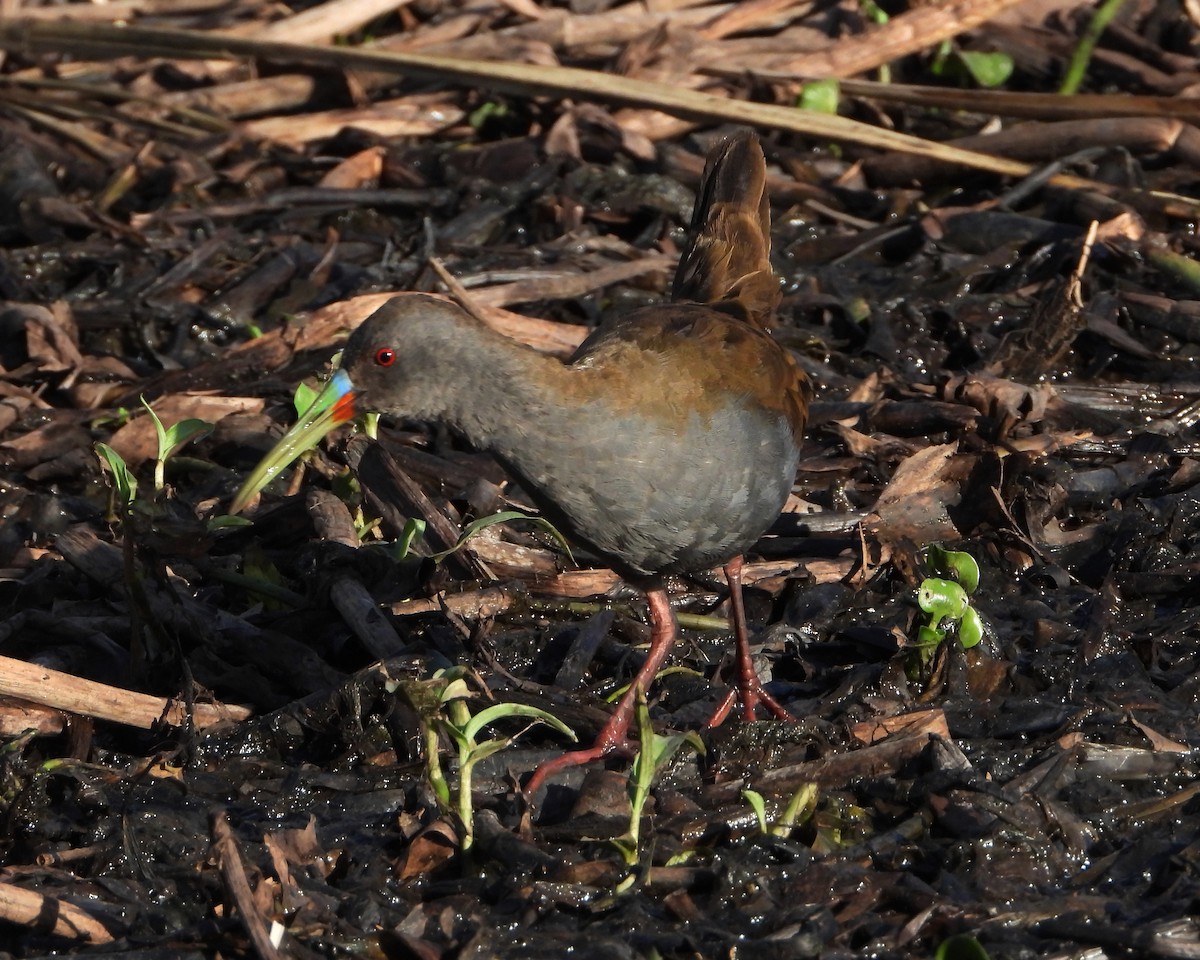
left=233, top=131, right=811, bottom=797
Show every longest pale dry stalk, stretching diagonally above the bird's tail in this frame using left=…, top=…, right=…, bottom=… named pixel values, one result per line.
left=0, top=19, right=1123, bottom=183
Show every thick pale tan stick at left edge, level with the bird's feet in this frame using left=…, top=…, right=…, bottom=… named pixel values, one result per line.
left=0, top=656, right=252, bottom=730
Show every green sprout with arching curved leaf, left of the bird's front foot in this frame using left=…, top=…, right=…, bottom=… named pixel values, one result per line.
left=398, top=666, right=577, bottom=852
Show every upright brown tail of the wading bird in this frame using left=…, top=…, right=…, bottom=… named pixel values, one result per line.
left=671, top=132, right=780, bottom=326
